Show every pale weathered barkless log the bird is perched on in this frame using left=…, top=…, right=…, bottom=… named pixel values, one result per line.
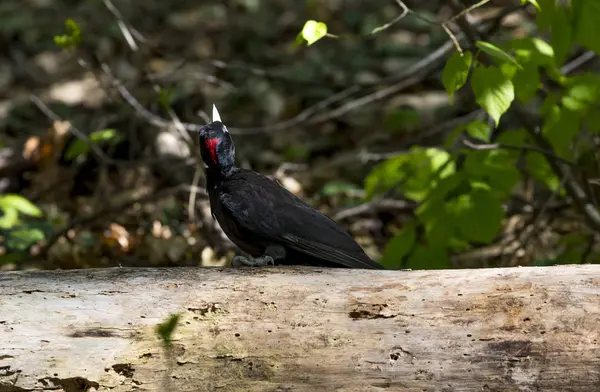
left=0, top=265, right=600, bottom=392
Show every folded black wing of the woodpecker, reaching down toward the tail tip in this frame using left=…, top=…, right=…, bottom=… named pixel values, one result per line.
left=220, top=170, right=382, bottom=268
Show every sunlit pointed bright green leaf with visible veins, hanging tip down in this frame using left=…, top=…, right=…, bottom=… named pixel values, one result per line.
left=471, top=66, right=515, bottom=126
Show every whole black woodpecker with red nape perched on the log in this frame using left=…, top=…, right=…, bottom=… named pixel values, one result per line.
left=199, top=105, right=383, bottom=269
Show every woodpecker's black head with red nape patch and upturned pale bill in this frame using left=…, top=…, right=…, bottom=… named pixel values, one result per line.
left=199, top=105, right=235, bottom=170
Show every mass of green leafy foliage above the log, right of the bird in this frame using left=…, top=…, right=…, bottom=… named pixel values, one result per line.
left=304, top=0, right=600, bottom=269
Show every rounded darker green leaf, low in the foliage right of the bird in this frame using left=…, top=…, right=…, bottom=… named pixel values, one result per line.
left=453, top=188, right=504, bottom=244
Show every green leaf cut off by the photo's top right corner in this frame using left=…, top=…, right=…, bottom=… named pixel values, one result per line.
left=572, top=0, right=600, bottom=54
